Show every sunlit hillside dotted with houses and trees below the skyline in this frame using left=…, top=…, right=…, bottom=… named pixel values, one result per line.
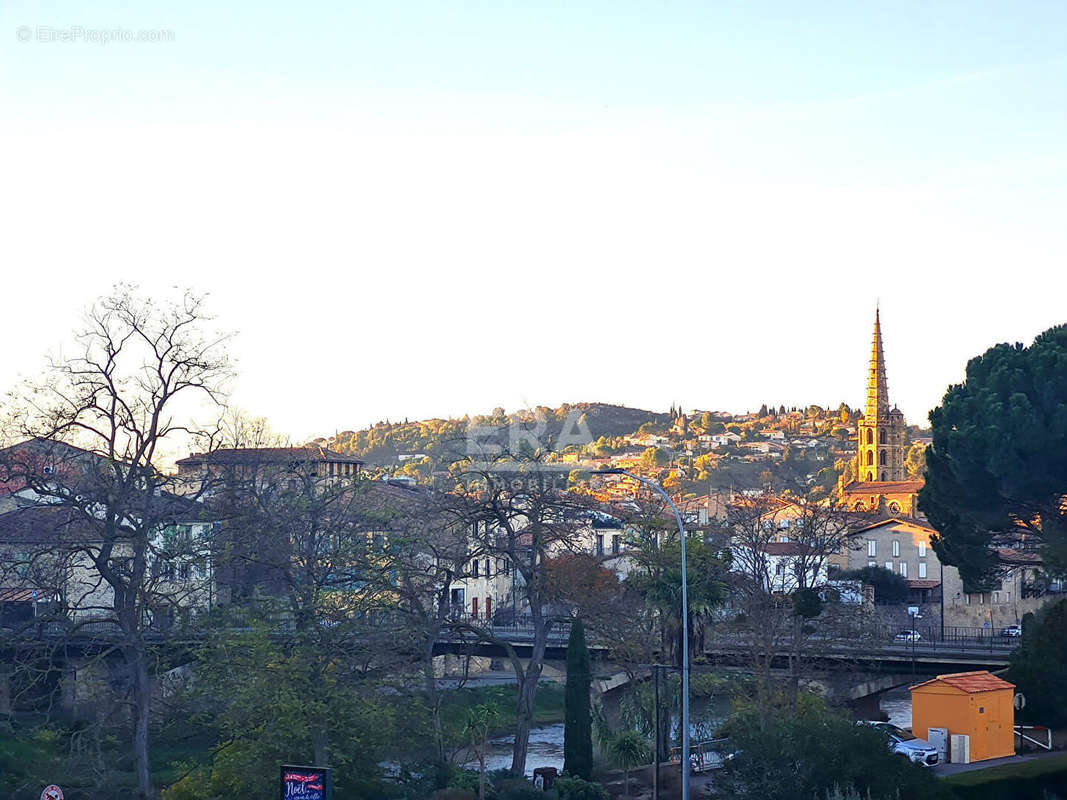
left=316, top=403, right=923, bottom=493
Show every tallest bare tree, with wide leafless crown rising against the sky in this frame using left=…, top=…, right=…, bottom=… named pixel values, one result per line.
left=5, top=287, right=230, bottom=798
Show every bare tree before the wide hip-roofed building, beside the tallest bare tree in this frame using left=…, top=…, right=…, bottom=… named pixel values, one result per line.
left=203, top=446, right=421, bottom=766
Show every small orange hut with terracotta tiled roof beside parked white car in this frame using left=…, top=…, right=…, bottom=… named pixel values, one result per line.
left=911, top=670, right=1015, bottom=762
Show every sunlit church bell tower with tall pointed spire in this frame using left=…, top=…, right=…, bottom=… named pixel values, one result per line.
left=856, top=309, right=905, bottom=483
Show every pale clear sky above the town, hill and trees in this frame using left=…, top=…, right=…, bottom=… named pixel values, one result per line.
left=0, top=0, right=1067, bottom=438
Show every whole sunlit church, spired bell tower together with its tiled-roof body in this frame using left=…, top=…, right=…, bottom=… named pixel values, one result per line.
left=841, top=310, right=923, bottom=517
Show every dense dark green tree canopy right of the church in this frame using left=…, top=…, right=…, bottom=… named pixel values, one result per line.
left=919, top=325, right=1067, bottom=588
